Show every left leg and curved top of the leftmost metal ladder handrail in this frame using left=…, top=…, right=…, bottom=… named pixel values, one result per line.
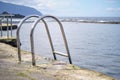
left=16, top=15, right=40, bottom=62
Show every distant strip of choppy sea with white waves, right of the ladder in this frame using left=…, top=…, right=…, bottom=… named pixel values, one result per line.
left=59, top=17, right=120, bottom=24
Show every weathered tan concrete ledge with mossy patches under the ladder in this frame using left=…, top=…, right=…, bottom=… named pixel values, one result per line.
left=0, top=43, right=115, bottom=80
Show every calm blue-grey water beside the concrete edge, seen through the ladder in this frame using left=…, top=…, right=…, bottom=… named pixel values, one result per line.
left=9, top=22, right=120, bottom=79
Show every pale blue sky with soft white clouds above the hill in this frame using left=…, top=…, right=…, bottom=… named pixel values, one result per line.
left=0, top=0, right=120, bottom=17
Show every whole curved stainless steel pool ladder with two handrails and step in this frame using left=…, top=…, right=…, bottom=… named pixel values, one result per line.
left=17, top=15, right=72, bottom=66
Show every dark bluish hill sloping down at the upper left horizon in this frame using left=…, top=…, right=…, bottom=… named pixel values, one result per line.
left=0, top=1, right=42, bottom=16
